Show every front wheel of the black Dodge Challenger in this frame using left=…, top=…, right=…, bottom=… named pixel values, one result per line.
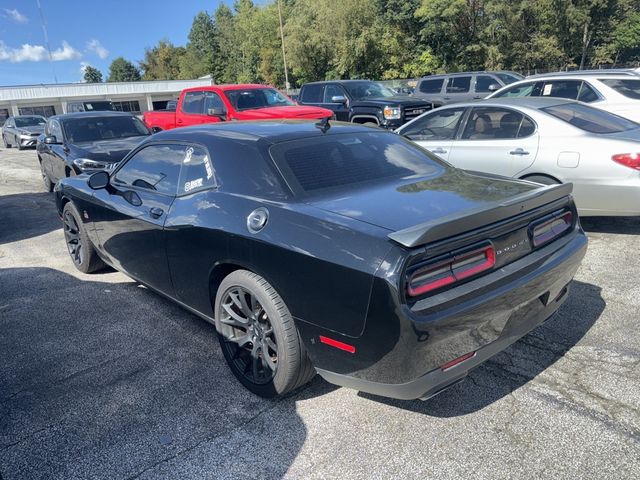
left=62, top=202, right=106, bottom=273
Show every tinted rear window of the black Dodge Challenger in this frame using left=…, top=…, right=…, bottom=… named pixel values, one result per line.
left=270, top=132, right=444, bottom=195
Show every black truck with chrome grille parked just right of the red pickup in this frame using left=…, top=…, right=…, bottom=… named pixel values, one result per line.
left=298, top=80, right=433, bottom=129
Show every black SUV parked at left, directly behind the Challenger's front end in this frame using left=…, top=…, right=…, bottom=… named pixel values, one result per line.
left=36, top=111, right=151, bottom=192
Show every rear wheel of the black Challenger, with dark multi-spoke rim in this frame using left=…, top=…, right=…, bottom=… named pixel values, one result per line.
left=215, top=270, right=316, bottom=398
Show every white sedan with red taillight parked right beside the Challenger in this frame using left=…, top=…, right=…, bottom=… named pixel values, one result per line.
left=396, top=98, right=640, bottom=216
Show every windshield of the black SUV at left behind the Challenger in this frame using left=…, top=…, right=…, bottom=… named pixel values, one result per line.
left=64, top=116, right=151, bottom=143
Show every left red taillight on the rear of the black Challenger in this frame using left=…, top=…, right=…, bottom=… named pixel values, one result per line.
left=407, top=245, right=496, bottom=297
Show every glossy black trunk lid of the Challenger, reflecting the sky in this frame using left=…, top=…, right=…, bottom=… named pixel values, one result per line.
left=307, top=168, right=536, bottom=232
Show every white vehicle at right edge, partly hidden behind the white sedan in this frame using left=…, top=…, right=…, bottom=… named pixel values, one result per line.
left=488, top=71, right=640, bottom=122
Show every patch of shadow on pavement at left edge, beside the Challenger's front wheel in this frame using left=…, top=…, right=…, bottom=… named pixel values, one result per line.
left=0, top=192, right=62, bottom=245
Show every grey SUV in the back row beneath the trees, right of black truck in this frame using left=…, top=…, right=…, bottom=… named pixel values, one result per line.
left=413, top=72, right=524, bottom=106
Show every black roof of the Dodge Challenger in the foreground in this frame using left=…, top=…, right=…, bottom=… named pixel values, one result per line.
left=149, top=119, right=387, bottom=144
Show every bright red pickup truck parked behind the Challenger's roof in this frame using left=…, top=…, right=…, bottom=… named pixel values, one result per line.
left=144, top=84, right=333, bottom=132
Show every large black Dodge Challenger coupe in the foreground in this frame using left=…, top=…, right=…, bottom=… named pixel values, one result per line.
left=56, top=121, right=587, bottom=399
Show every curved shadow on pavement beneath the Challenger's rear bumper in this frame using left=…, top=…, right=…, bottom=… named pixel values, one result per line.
left=359, top=280, right=606, bottom=417
